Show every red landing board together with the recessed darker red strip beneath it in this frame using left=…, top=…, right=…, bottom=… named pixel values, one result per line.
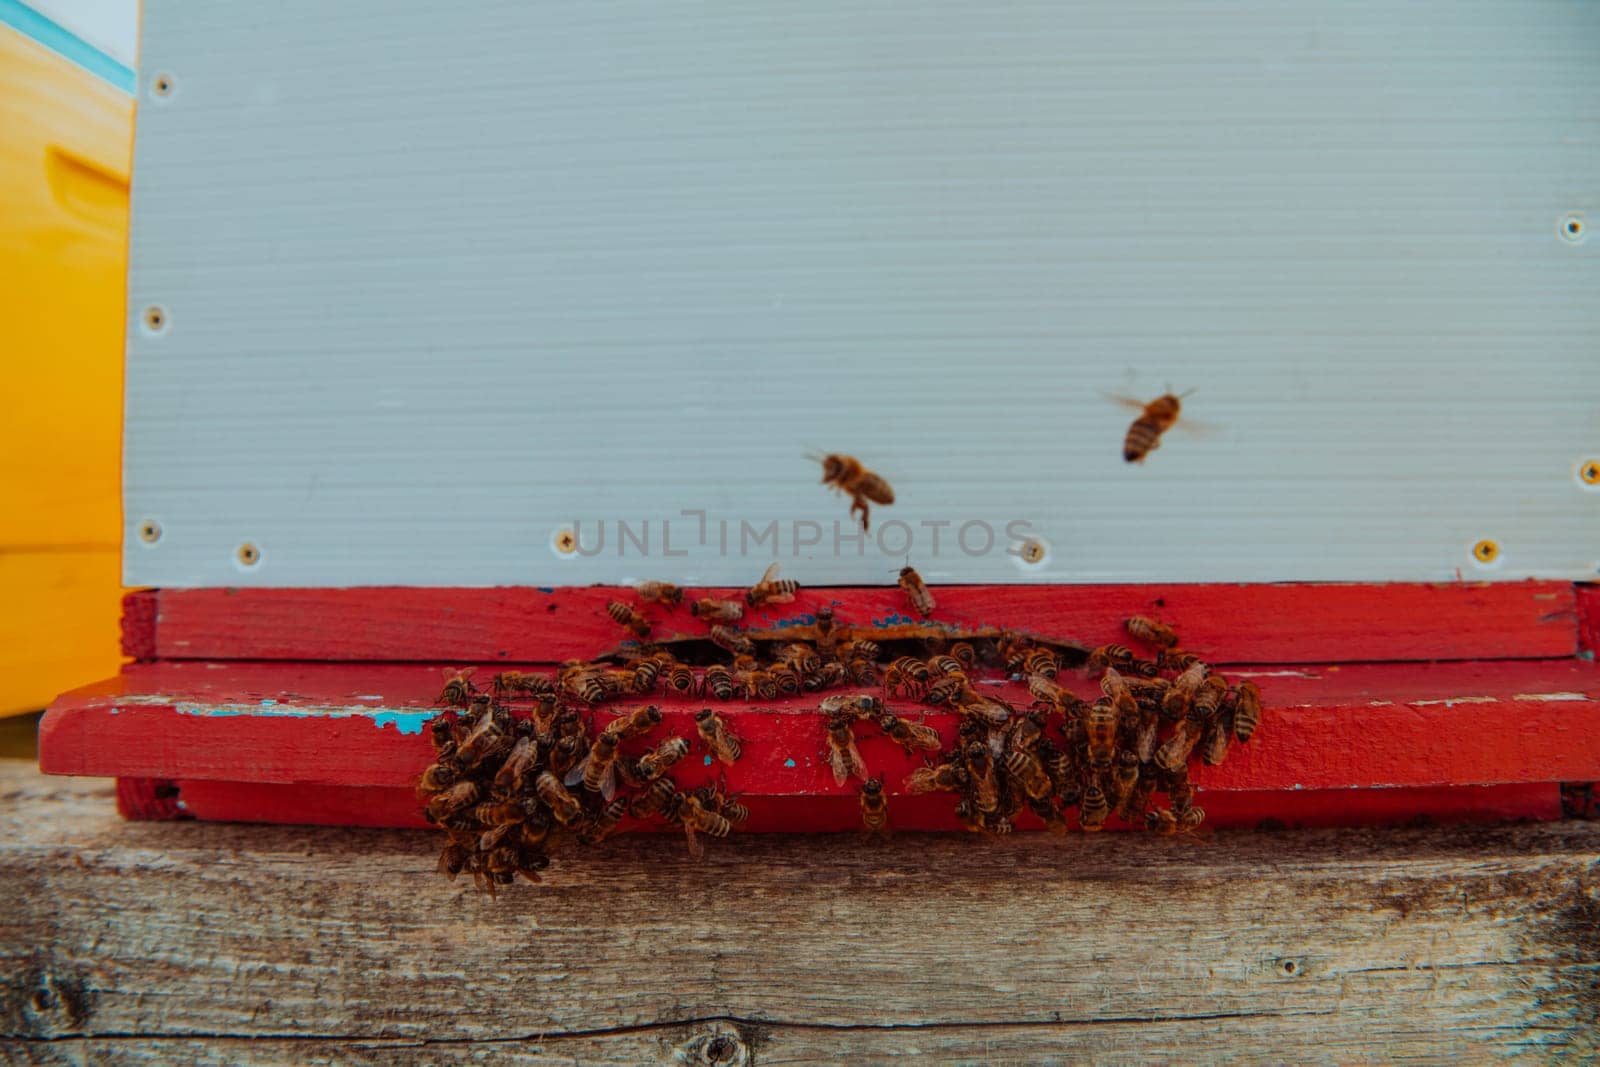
left=40, top=657, right=1600, bottom=830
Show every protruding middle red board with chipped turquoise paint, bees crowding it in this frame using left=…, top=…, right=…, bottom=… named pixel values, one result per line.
left=40, top=657, right=1600, bottom=799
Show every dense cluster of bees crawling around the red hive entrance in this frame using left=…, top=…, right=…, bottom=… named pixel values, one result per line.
left=419, top=566, right=1261, bottom=893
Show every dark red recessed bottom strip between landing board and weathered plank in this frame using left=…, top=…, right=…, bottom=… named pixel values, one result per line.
left=162, top=781, right=1562, bottom=833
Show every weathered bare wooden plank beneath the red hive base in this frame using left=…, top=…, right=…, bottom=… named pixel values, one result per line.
left=0, top=765, right=1600, bottom=1064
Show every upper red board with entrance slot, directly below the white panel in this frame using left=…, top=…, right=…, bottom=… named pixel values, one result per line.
left=130, top=574, right=1578, bottom=664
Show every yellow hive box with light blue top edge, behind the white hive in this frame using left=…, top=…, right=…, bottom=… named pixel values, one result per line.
left=0, top=0, right=133, bottom=715
